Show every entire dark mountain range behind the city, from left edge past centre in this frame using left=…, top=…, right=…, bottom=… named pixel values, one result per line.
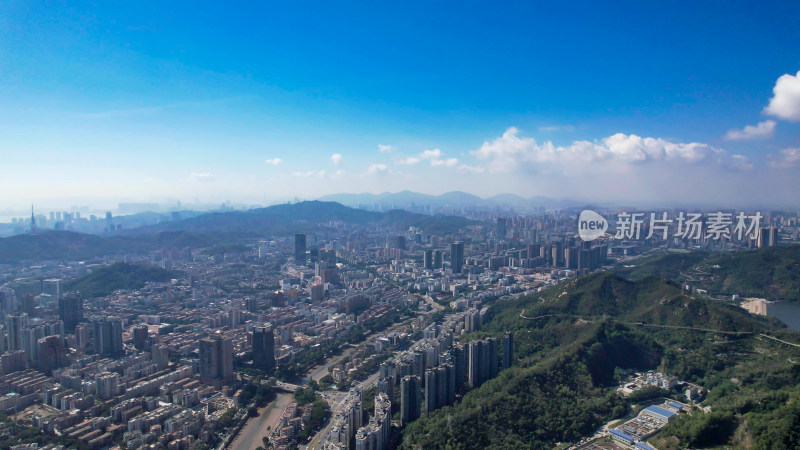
left=0, top=201, right=477, bottom=264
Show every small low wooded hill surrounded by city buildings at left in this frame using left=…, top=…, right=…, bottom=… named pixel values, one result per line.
left=65, top=263, right=181, bottom=298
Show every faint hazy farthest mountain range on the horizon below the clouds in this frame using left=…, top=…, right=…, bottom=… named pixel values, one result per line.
left=320, top=191, right=583, bottom=211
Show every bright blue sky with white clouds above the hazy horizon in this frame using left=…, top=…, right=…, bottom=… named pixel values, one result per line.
left=0, top=1, right=800, bottom=209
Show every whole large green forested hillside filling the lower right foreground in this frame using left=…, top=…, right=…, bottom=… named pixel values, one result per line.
left=402, top=273, right=800, bottom=449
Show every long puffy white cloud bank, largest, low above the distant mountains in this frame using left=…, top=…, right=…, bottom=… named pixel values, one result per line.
left=472, top=127, right=747, bottom=173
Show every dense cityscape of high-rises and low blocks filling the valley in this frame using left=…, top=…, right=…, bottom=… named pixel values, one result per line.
left=0, top=202, right=798, bottom=449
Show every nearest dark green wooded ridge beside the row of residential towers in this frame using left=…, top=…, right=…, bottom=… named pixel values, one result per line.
left=401, top=324, right=659, bottom=449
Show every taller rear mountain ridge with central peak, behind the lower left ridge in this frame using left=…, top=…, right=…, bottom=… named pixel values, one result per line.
left=128, top=201, right=474, bottom=235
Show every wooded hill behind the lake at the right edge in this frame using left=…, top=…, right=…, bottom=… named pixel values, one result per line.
left=617, top=245, right=800, bottom=302
